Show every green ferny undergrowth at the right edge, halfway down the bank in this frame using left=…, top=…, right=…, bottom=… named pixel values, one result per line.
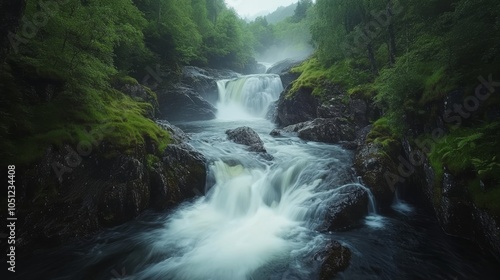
left=429, top=121, right=500, bottom=216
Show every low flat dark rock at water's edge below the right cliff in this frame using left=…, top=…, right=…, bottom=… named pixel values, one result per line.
left=283, top=118, right=356, bottom=143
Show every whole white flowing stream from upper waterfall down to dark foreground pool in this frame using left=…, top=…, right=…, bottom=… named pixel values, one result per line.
left=14, top=75, right=499, bottom=280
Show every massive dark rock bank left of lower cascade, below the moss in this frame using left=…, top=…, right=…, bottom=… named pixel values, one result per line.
left=16, top=123, right=206, bottom=252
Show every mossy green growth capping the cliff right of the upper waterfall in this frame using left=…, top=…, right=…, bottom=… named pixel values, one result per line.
left=288, top=58, right=372, bottom=98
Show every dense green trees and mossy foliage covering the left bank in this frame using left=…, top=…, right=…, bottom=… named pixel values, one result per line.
left=0, top=0, right=262, bottom=164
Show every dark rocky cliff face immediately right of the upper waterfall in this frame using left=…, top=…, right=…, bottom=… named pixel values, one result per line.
left=274, top=79, right=375, bottom=149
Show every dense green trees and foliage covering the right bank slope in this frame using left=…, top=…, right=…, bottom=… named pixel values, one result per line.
left=290, top=0, right=500, bottom=213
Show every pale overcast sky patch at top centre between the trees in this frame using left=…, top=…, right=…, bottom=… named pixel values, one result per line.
left=226, top=0, right=298, bottom=18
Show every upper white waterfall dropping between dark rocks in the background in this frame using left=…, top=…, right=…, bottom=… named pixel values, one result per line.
left=217, top=74, right=283, bottom=120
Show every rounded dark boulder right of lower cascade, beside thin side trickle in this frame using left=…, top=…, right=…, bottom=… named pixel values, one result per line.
left=319, top=185, right=369, bottom=231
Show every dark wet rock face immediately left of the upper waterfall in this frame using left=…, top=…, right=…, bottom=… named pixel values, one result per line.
left=158, top=85, right=217, bottom=121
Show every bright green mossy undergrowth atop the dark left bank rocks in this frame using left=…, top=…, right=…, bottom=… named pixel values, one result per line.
left=0, top=65, right=171, bottom=165
